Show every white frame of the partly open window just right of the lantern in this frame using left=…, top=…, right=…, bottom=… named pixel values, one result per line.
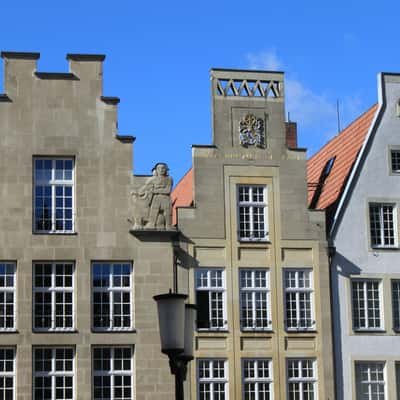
left=195, top=267, right=228, bottom=331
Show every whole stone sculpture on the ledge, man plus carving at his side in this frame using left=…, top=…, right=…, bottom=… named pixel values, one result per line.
left=129, top=163, right=175, bottom=230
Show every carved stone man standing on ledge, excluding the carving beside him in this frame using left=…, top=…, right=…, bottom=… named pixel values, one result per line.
left=139, top=163, right=172, bottom=230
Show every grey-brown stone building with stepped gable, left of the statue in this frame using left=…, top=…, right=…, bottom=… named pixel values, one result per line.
left=0, top=52, right=180, bottom=400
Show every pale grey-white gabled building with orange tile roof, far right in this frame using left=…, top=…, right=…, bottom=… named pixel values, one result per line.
left=308, top=73, right=400, bottom=400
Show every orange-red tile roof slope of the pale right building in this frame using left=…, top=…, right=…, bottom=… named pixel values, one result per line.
left=307, top=104, right=378, bottom=209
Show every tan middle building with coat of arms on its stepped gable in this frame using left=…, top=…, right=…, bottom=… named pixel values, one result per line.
left=172, top=69, right=334, bottom=400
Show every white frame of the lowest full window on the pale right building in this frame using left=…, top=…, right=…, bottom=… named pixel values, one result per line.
left=355, top=361, right=387, bottom=400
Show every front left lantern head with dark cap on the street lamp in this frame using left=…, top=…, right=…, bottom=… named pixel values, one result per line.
left=153, top=293, right=187, bottom=354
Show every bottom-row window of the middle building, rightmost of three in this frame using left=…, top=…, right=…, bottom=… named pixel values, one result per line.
left=287, top=359, right=317, bottom=400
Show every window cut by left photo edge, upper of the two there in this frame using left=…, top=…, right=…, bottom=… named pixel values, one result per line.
left=0, top=262, right=16, bottom=331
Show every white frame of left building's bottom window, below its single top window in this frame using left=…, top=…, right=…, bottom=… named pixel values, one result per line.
left=32, top=346, right=76, bottom=400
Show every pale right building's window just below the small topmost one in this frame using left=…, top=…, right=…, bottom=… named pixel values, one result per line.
left=369, top=203, right=397, bottom=247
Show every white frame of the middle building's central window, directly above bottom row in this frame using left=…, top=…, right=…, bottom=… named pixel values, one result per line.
left=239, top=268, right=272, bottom=331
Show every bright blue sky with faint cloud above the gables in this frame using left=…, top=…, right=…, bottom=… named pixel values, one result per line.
left=0, top=0, right=400, bottom=181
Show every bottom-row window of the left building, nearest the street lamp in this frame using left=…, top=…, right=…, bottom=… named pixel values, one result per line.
left=93, top=347, right=133, bottom=400
